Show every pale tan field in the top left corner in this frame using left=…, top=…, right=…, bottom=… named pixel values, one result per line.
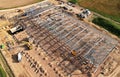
left=0, top=0, right=43, bottom=10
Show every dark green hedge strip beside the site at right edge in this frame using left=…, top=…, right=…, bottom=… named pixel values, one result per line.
left=92, top=17, right=120, bottom=37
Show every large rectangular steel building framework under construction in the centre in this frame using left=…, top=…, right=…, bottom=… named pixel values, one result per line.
left=11, top=4, right=117, bottom=74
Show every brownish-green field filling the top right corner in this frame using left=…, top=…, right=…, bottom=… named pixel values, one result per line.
left=78, top=0, right=120, bottom=22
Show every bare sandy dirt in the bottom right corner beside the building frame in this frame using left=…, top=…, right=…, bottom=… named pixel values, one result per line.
left=98, top=45, right=120, bottom=77
